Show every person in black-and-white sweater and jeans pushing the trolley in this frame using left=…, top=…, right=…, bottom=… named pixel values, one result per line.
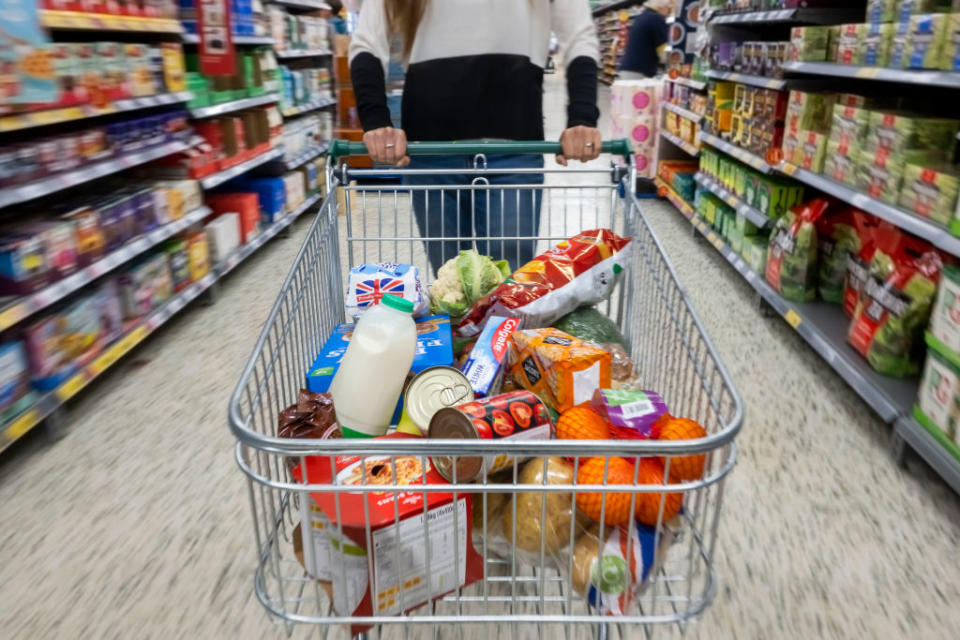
left=349, top=0, right=601, bottom=269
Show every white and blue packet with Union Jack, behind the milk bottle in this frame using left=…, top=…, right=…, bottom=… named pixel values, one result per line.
left=346, top=262, right=430, bottom=320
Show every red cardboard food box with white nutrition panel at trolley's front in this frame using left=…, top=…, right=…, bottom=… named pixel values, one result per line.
left=293, top=433, right=483, bottom=634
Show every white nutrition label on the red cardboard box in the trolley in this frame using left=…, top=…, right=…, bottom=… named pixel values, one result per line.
left=372, top=498, right=467, bottom=615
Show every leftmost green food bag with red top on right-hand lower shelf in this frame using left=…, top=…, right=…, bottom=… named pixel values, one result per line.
left=766, top=198, right=828, bottom=302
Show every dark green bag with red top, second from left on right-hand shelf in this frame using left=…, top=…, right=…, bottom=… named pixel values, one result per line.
left=817, top=209, right=874, bottom=304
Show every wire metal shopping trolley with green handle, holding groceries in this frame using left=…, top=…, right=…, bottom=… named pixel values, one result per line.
left=229, top=142, right=743, bottom=638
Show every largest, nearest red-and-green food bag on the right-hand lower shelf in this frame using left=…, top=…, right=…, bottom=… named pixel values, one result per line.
left=848, top=230, right=942, bottom=377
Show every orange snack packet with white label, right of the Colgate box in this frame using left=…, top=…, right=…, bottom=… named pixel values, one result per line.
left=508, top=329, right=611, bottom=413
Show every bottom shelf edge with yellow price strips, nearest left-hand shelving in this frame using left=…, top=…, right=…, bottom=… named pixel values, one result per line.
left=0, top=273, right=217, bottom=458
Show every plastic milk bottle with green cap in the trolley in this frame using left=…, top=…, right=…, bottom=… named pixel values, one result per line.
left=330, top=294, right=417, bottom=438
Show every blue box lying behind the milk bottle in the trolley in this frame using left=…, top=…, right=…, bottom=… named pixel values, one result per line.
left=307, top=316, right=453, bottom=424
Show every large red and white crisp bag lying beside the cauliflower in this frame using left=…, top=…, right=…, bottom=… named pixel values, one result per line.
left=457, top=229, right=630, bottom=336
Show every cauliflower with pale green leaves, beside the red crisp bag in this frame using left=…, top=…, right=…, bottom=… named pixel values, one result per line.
left=430, top=249, right=510, bottom=318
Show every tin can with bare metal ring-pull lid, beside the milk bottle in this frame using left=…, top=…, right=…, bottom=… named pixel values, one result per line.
left=397, top=366, right=473, bottom=436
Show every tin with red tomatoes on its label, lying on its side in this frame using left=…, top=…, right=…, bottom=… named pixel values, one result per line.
left=428, top=390, right=552, bottom=483
